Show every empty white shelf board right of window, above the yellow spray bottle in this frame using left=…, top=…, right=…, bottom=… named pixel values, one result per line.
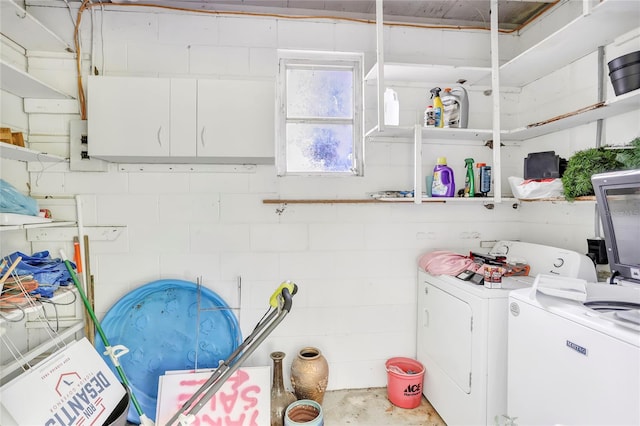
left=365, top=62, right=491, bottom=85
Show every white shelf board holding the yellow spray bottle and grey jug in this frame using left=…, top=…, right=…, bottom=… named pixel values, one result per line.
left=365, top=126, right=493, bottom=142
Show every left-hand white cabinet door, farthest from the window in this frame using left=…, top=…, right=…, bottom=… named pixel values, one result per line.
left=87, top=77, right=171, bottom=161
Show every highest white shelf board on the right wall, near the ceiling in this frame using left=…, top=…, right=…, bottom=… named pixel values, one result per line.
left=490, top=0, right=640, bottom=87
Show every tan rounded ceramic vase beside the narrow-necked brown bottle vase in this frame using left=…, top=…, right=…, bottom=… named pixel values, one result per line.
left=291, top=347, right=329, bottom=404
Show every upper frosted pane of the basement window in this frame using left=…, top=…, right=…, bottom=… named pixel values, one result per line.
left=287, top=68, right=353, bottom=118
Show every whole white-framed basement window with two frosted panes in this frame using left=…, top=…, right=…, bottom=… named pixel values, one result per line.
left=276, top=51, right=364, bottom=176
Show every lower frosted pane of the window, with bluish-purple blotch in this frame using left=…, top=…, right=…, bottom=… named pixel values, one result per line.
left=287, top=123, right=353, bottom=172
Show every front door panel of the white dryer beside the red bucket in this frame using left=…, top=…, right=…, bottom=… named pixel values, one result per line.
left=417, top=282, right=472, bottom=393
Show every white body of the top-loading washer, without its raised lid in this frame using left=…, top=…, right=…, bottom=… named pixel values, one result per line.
left=507, top=283, right=640, bottom=426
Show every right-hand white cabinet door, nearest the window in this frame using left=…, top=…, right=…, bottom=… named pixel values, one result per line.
left=197, top=80, right=275, bottom=162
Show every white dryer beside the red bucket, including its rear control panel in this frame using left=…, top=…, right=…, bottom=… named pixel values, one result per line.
left=417, top=241, right=596, bottom=425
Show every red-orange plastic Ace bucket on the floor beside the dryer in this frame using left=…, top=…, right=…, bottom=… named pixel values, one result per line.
left=385, top=357, right=424, bottom=408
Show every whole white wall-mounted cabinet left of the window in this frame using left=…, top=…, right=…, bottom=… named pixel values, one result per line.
left=87, top=77, right=275, bottom=164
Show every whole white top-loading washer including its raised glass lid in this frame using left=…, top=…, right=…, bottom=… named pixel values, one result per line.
left=508, top=170, right=640, bottom=426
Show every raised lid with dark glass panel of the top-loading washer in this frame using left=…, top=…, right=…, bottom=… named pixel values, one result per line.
left=591, top=170, right=640, bottom=283
